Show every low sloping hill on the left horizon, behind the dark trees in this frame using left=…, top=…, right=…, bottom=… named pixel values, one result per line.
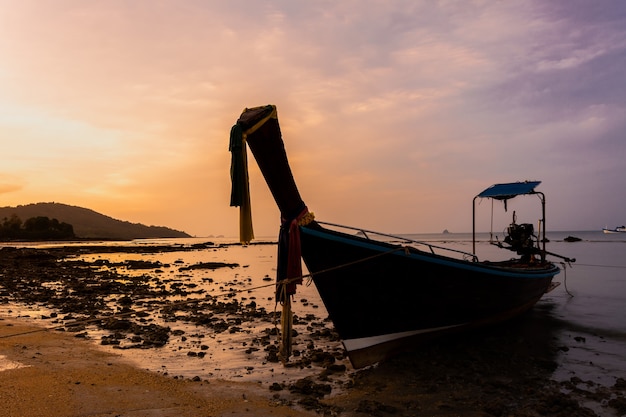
left=0, top=203, right=190, bottom=240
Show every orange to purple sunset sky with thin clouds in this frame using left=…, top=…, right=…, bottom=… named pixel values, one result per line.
left=0, top=0, right=626, bottom=237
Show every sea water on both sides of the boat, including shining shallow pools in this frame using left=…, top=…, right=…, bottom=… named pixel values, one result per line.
left=0, top=231, right=626, bottom=386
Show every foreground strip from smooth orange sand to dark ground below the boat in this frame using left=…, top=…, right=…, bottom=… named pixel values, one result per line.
left=0, top=319, right=624, bottom=417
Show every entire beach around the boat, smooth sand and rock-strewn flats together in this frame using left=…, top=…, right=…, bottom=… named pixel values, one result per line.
left=0, top=242, right=626, bottom=417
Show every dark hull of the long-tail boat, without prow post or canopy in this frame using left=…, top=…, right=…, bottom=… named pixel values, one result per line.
left=301, top=223, right=559, bottom=368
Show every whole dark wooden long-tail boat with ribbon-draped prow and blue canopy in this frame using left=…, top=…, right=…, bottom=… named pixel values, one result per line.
left=230, top=105, right=574, bottom=368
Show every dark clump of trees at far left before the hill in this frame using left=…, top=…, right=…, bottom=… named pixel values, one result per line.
left=0, top=214, right=75, bottom=240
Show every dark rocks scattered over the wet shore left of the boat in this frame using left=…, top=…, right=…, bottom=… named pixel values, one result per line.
left=0, top=244, right=345, bottom=380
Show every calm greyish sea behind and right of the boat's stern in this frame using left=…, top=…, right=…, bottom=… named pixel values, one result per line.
left=406, top=230, right=626, bottom=386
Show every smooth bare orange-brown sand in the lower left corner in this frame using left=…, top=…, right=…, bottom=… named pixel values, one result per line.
left=0, top=318, right=315, bottom=417
